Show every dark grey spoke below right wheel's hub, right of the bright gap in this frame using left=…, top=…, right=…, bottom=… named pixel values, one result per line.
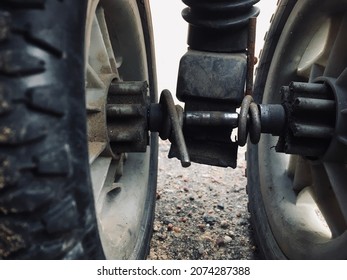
left=311, top=163, right=347, bottom=237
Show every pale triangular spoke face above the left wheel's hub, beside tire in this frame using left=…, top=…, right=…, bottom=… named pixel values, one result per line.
left=89, top=12, right=112, bottom=75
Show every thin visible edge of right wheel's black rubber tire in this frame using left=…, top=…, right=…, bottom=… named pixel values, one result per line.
left=247, top=0, right=297, bottom=259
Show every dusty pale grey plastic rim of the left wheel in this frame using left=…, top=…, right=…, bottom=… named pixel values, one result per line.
left=86, top=0, right=151, bottom=259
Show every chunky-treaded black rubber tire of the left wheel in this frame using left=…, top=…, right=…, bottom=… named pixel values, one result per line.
left=0, top=0, right=158, bottom=259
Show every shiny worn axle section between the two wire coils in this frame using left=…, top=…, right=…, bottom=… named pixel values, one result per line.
left=184, top=111, right=239, bottom=128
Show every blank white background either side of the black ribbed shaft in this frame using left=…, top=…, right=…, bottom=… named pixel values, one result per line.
left=150, top=0, right=277, bottom=95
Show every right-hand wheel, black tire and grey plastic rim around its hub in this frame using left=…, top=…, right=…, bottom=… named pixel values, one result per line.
left=247, top=0, right=347, bottom=259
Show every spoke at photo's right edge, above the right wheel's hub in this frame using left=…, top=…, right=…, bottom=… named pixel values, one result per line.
left=324, top=14, right=347, bottom=78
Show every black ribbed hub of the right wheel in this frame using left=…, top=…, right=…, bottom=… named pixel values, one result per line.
left=276, top=82, right=335, bottom=157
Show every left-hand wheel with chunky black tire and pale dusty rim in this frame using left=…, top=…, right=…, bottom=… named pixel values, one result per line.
left=0, top=0, right=158, bottom=259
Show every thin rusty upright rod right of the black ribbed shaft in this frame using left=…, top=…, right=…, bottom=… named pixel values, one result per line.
left=246, top=17, right=257, bottom=95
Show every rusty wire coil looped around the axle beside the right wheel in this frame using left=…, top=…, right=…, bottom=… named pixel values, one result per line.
left=237, top=95, right=261, bottom=146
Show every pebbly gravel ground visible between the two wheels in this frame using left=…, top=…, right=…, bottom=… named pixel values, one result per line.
left=148, top=141, right=255, bottom=260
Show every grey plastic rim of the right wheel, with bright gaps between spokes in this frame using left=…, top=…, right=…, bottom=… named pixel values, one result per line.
left=258, top=0, right=347, bottom=259
